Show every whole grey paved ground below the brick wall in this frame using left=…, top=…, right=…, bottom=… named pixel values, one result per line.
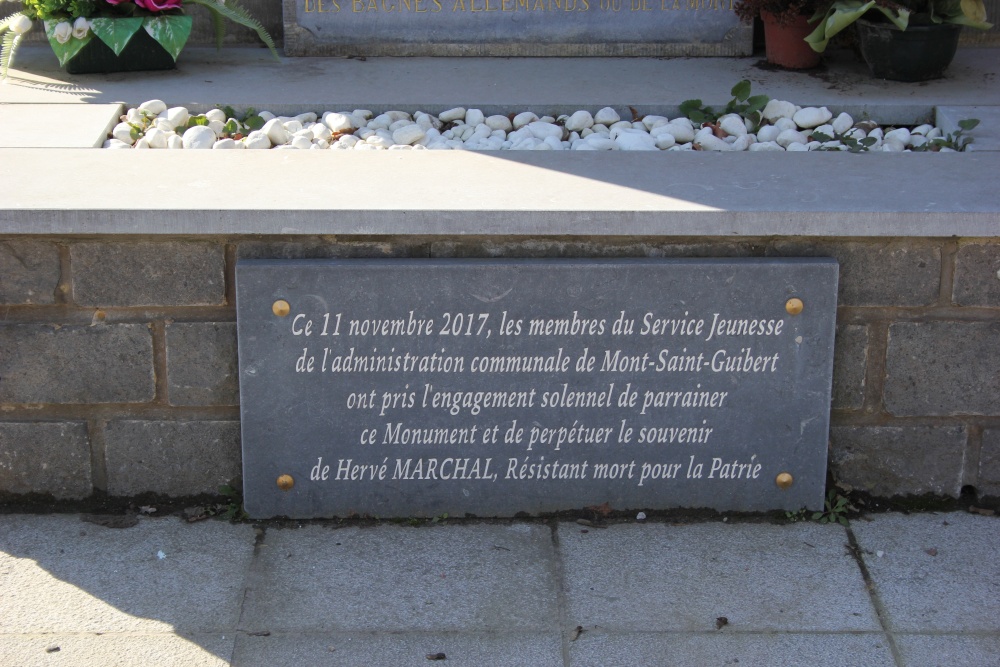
left=0, top=513, right=1000, bottom=667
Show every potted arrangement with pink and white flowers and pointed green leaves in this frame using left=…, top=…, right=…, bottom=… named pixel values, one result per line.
left=0, top=0, right=277, bottom=79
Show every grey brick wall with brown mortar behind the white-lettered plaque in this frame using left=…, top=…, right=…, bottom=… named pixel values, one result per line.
left=0, top=237, right=1000, bottom=499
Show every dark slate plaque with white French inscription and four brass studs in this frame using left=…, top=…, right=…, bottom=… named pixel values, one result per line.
left=236, top=259, right=838, bottom=518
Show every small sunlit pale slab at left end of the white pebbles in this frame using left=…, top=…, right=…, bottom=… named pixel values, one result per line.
left=0, top=103, right=122, bottom=148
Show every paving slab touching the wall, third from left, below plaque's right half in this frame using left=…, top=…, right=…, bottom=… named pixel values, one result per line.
left=559, top=522, right=881, bottom=632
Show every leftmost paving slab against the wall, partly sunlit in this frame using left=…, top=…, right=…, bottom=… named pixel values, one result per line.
left=0, top=515, right=254, bottom=634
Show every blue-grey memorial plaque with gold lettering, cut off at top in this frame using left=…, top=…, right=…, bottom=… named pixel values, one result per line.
left=284, top=0, right=753, bottom=56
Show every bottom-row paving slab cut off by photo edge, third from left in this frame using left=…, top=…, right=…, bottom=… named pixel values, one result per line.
left=569, top=627, right=896, bottom=667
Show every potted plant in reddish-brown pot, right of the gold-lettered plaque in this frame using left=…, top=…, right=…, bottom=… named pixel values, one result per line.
left=733, top=0, right=825, bottom=69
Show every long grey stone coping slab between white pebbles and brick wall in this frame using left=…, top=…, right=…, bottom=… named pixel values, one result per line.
left=0, top=149, right=1000, bottom=237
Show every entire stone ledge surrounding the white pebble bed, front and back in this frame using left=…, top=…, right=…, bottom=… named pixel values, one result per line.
left=0, top=45, right=1000, bottom=237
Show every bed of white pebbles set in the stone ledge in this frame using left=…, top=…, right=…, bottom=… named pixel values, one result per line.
left=104, top=100, right=954, bottom=152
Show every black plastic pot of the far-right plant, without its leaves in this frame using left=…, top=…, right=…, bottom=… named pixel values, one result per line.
left=857, top=19, right=962, bottom=81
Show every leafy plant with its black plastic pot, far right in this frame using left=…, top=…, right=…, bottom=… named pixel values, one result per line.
left=806, top=0, right=992, bottom=81
